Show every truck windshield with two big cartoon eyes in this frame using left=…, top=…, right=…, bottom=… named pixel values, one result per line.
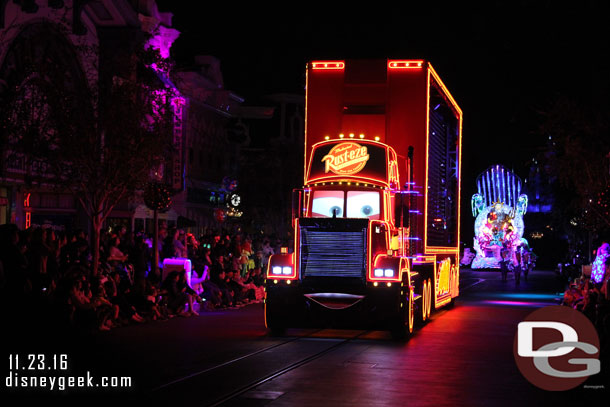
left=311, top=191, right=381, bottom=219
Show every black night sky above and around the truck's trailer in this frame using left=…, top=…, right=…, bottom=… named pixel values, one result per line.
left=157, top=0, right=610, bottom=210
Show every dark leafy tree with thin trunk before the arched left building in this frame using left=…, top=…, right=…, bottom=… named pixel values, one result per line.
left=0, top=29, right=175, bottom=275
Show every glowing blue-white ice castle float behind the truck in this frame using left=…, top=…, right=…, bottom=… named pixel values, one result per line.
left=471, top=165, right=527, bottom=269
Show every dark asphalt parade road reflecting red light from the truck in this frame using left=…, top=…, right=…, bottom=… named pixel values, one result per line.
left=0, top=269, right=610, bottom=407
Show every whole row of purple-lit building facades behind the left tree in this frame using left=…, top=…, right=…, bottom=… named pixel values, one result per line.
left=0, top=0, right=248, bottom=239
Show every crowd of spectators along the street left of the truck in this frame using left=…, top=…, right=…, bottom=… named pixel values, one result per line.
left=0, top=224, right=280, bottom=331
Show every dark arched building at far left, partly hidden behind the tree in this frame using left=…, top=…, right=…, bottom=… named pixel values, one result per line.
left=0, top=0, right=179, bottom=233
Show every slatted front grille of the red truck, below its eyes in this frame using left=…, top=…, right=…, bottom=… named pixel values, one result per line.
left=300, top=226, right=366, bottom=278
